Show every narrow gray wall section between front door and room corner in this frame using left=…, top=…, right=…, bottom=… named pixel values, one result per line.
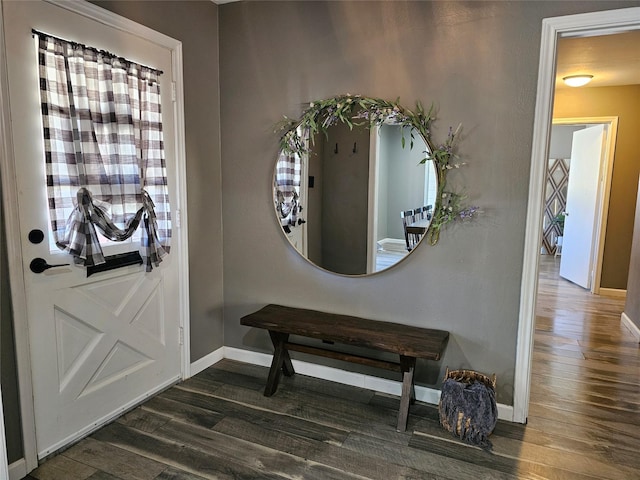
left=93, top=1, right=224, bottom=361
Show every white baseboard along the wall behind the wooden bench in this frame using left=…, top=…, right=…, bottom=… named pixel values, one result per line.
left=224, top=347, right=513, bottom=422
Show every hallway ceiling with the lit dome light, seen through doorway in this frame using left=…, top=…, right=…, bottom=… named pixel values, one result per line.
left=556, top=30, right=640, bottom=88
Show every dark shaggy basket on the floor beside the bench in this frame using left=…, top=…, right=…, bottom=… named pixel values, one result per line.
left=438, top=368, right=498, bottom=448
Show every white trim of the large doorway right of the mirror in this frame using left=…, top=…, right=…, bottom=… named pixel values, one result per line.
left=513, top=7, right=640, bottom=423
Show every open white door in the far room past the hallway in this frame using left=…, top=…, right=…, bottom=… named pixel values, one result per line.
left=560, top=125, right=605, bottom=289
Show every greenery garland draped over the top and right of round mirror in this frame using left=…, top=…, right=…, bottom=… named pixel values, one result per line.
left=276, top=93, right=479, bottom=245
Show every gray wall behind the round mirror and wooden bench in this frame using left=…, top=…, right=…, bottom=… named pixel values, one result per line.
left=219, top=1, right=637, bottom=404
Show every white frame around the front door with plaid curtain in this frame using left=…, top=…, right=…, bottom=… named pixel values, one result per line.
left=0, top=0, right=191, bottom=472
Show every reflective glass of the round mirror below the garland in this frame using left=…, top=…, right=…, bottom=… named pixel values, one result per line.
left=274, top=123, right=437, bottom=275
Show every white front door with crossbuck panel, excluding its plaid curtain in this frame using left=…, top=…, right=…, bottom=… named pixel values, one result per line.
left=2, top=1, right=184, bottom=458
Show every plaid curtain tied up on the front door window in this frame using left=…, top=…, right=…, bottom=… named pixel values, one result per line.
left=33, top=31, right=171, bottom=271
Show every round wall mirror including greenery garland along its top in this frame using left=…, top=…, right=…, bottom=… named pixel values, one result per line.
left=273, top=95, right=453, bottom=275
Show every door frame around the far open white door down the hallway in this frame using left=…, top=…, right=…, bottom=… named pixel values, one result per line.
left=552, top=116, right=618, bottom=295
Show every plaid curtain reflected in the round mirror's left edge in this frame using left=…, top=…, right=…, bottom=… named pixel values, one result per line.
left=274, top=152, right=302, bottom=227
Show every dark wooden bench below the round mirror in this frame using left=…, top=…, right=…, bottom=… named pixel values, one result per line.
left=240, top=305, right=449, bottom=432
